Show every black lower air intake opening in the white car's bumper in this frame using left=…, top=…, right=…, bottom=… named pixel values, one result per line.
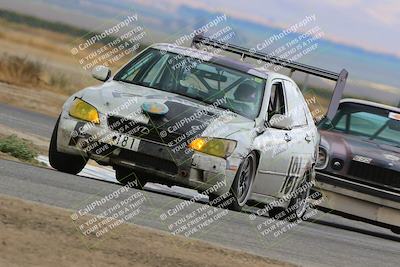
left=119, top=149, right=178, bottom=175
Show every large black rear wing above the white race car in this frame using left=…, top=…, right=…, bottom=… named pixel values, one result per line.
left=191, top=35, right=349, bottom=120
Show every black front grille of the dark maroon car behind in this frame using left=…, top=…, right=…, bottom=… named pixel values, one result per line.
left=348, top=161, right=400, bottom=188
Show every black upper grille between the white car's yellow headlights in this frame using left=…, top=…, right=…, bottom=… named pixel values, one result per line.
left=108, top=116, right=180, bottom=144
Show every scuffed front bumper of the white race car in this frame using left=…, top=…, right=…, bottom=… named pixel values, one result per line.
left=57, top=113, right=240, bottom=194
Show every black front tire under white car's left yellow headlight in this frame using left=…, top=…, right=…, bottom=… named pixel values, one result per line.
left=49, top=117, right=87, bottom=174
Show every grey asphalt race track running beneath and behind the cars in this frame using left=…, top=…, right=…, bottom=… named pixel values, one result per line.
left=0, top=105, right=400, bottom=266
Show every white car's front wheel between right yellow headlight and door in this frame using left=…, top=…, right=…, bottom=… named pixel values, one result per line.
left=209, top=152, right=257, bottom=211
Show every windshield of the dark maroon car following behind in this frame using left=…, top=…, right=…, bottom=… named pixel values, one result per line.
left=322, top=104, right=400, bottom=147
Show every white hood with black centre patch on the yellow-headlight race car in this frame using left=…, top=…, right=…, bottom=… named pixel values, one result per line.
left=71, top=81, right=255, bottom=139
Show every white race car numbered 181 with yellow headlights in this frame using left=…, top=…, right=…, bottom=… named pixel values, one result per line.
left=49, top=36, right=346, bottom=220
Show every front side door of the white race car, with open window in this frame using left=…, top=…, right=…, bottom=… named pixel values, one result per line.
left=253, top=79, right=294, bottom=197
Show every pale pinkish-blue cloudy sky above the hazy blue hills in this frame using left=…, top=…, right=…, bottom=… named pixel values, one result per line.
left=139, top=0, right=400, bottom=57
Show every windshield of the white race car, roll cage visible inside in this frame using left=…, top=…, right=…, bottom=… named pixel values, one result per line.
left=114, top=48, right=265, bottom=119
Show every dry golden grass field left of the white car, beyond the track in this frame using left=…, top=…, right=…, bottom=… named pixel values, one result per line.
left=0, top=19, right=124, bottom=117
